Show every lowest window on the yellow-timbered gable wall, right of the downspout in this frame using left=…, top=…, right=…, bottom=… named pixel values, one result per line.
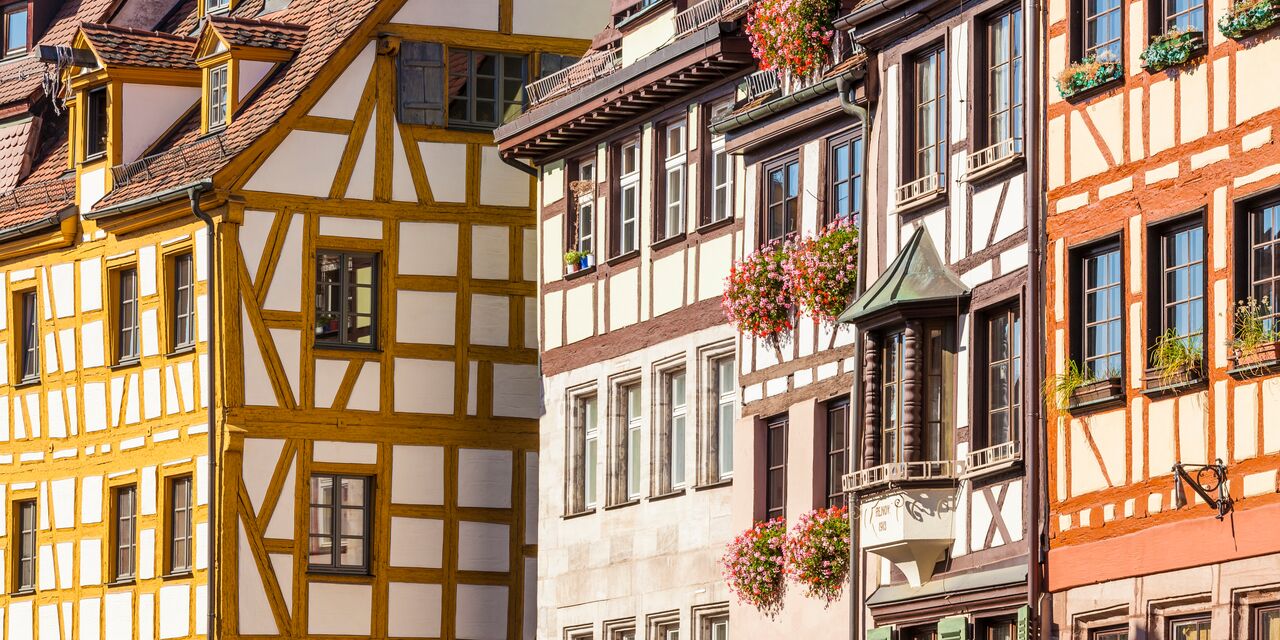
left=307, top=474, right=372, bottom=573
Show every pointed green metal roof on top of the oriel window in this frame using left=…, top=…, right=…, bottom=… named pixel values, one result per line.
left=840, top=225, right=969, bottom=323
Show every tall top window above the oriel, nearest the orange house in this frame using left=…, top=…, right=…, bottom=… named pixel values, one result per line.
left=986, top=5, right=1023, bottom=152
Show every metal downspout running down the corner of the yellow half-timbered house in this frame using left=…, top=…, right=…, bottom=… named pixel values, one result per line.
left=187, top=184, right=221, bottom=639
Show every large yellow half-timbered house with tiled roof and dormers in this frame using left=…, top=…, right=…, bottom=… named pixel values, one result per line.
left=0, top=0, right=607, bottom=640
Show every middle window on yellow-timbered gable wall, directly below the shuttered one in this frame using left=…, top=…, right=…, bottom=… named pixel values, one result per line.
left=315, top=251, right=378, bottom=348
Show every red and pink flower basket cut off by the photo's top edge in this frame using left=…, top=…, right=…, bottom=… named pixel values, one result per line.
left=746, top=0, right=838, bottom=77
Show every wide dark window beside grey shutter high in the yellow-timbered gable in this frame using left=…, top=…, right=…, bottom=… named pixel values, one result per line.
left=445, top=47, right=526, bottom=129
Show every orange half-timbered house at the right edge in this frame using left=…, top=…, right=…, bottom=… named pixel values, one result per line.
left=1046, top=0, right=1280, bottom=640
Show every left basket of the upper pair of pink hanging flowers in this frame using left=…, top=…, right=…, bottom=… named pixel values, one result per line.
left=721, top=242, right=795, bottom=347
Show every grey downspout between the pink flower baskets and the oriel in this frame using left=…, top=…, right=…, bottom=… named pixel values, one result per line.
left=836, top=77, right=872, bottom=640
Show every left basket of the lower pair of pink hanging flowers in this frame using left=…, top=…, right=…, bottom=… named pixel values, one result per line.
left=721, top=518, right=787, bottom=618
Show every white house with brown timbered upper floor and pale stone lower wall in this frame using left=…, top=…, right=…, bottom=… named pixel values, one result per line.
left=497, top=0, right=751, bottom=640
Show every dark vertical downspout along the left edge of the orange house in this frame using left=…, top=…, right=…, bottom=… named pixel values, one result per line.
left=1023, top=0, right=1053, bottom=640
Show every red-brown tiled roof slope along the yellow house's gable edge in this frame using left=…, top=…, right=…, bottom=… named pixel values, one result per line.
left=95, top=0, right=379, bottom=211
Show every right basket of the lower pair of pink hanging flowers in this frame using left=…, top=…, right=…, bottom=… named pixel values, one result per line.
left=783, top=507, right=850, bottom=607
